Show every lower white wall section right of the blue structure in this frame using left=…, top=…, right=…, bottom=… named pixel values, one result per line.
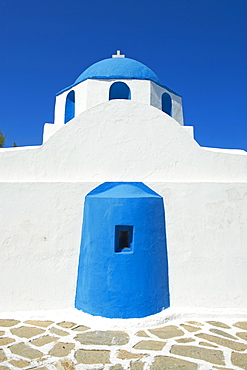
left=149, top=182, right=247, bottom=309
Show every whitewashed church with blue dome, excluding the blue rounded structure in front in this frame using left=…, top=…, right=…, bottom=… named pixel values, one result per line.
left=0, top=52, right=247, bottom=318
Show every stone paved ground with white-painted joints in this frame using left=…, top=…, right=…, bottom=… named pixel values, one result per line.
left=0, top=318, right=247, bottom=370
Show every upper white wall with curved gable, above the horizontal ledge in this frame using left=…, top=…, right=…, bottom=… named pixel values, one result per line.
left=0, top=100, right=247, bottom=182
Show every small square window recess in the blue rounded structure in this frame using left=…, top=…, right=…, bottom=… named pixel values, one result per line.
left=115, top=225, right=133, bottom=253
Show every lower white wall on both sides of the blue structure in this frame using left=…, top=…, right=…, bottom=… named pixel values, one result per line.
left=0, top=182, right=247, bottom=312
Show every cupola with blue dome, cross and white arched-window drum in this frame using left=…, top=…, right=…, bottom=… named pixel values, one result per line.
left=44, top=50, right=183, bottom=141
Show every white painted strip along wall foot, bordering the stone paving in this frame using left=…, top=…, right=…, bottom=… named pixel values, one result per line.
left=0, top=307, right=247, bottom=331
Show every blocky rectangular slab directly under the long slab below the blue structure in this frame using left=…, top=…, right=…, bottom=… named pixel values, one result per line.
left=75, top=349, right=111, bottom=364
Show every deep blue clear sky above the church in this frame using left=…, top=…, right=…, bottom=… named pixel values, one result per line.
left=0, top=0, right=247, bottom=150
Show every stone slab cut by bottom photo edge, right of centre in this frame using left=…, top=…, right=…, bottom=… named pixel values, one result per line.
left=150, top=356, right=197, bottom=370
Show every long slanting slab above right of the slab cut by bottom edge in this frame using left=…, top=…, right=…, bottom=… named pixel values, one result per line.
left=170, top=344, right=225, bottom=365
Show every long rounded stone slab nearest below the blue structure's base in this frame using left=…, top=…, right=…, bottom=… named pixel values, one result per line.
left=75, top=331, right=129, bottom=346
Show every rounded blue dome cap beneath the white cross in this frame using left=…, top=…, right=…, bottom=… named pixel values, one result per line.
left=74, top=58, right=159, bottom=85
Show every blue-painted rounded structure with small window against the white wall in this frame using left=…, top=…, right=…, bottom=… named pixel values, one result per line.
left=75, top=182, right=169, bottom=318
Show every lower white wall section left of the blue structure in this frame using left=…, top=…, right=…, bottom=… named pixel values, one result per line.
left=0, top=183, right=92, bottom=311
